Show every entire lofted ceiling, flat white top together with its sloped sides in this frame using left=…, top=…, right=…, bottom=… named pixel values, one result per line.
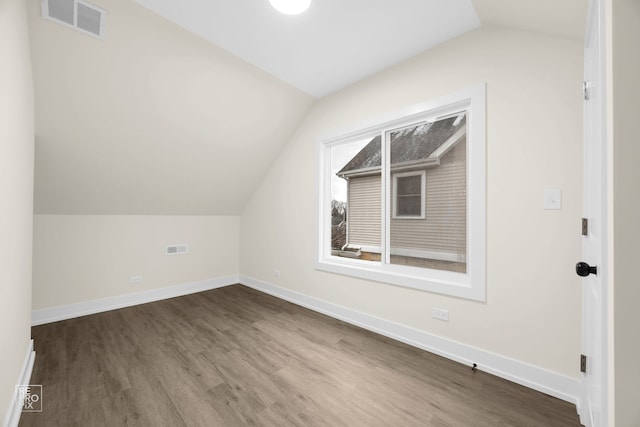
left=28, top=0, right=586, bottom=215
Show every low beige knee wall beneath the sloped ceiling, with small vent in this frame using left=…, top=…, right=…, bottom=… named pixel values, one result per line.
left=33, top=215, right=239, bottom=310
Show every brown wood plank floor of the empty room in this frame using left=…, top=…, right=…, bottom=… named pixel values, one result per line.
left=20, top=285, right=580, bottom=427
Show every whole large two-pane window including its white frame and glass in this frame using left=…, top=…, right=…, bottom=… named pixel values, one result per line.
left=317, top=85, right=486, bottom=300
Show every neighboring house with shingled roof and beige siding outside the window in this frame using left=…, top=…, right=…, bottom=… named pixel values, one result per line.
left=337, top=113, right=467, bottom=272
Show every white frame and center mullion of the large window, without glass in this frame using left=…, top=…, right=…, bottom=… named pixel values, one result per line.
left=315, top=83, right=486, bottom=301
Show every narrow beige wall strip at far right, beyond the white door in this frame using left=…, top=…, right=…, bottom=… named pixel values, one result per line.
left=612, top=0, right=640, bottom=427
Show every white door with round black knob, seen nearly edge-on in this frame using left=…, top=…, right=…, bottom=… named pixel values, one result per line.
left=576, top=0, right=607, bottom=427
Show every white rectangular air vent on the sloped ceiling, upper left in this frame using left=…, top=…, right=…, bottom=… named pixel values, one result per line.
left=41, top=0, right=107, bottom=39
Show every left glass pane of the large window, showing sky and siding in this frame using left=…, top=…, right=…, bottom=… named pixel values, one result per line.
left=331, top=136, right=382, bottom=262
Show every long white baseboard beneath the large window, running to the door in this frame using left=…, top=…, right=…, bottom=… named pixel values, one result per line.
left=240, top=275, right=580, bottom=404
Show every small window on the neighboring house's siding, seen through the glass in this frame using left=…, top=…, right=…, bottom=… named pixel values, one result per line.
left=393, top=171, right=426, bottom=219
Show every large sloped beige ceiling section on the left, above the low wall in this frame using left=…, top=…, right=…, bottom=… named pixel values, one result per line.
left=28, top=0, right=313, bottom=215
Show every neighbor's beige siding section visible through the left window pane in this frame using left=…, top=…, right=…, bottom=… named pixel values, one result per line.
left=347, top=175, right=382, bottom=247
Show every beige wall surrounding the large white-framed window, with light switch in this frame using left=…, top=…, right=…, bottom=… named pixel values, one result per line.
left=240, top=28, right=582, bottom=378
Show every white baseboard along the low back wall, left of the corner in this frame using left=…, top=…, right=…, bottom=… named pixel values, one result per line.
left=31, top=275, right=239, bottom=326
